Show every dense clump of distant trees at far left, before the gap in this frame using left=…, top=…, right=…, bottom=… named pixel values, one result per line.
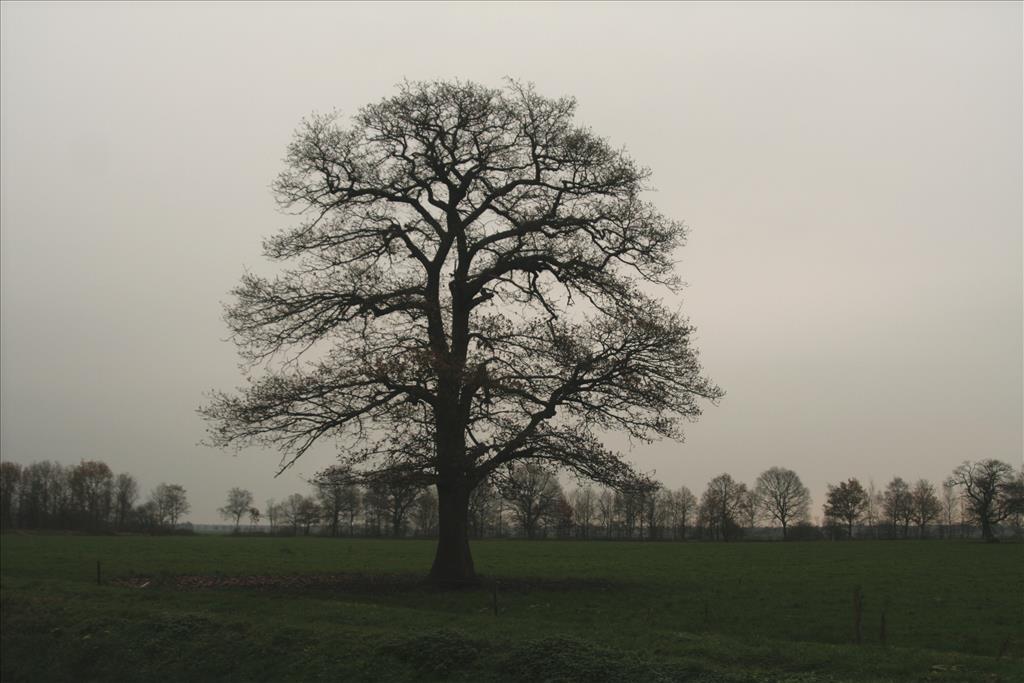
left=0, top=460, right=189, bottom=532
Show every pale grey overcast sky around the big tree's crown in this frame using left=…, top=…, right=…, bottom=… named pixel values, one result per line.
left=0, top=2, right=1024, bottom=522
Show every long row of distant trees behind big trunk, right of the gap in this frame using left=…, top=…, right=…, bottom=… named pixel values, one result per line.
left=211, top=460, right=1024, bottom=541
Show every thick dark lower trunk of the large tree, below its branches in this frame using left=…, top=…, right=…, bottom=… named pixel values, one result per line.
left=430, top=481, right=477, bottom=588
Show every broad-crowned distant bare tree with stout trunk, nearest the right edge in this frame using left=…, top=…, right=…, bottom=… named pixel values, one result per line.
left=947, top=460, right=1024, bottom=543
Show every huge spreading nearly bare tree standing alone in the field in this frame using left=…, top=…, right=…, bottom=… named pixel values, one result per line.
left=201, top=82, right=723, bottom=585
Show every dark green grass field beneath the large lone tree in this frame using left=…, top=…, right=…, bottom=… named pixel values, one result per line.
left=0, top=536, right=1024, bottom=682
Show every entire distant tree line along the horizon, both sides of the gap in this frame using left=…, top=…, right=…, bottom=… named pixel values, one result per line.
left=0, top=460, right=1024, bottom=541
